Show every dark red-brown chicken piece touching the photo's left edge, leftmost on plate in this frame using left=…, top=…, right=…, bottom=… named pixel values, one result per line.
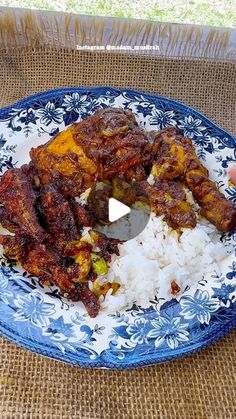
left=0, top=169, right=46, bottom=242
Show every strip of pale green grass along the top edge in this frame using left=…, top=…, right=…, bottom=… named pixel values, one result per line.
left=0, top=0, right=236, bottom=27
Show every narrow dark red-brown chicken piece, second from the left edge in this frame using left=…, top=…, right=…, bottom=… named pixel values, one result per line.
left=39, top=185, right=80, bottom=250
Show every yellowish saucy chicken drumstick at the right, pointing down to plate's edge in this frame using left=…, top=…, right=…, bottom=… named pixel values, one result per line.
left=152, top=128, right=236, bottom=232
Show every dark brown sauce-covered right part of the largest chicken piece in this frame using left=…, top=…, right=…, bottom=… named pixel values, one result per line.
left=75, top=108, right=151, bottom=180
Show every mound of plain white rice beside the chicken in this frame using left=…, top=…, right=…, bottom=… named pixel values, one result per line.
left=95, top=214, right=227, bottom=312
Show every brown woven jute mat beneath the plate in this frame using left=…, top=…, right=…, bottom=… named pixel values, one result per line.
left=0, top=48, right=236, bottom=419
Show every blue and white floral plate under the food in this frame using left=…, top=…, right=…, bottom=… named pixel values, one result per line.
left=0, top=87, right=236, bottom=369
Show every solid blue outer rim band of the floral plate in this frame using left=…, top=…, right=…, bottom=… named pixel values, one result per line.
left=0, top=86, right=236, bottom=370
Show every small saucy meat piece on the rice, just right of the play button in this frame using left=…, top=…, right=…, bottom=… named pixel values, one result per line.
left=141, top=180, right=197, bottom=228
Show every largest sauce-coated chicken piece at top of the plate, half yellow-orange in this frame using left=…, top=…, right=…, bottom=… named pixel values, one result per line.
left=29, top=108, right=151, bottom=197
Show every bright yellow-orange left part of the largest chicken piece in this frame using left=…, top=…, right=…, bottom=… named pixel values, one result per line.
left=28, top=124, right=97, bottom=196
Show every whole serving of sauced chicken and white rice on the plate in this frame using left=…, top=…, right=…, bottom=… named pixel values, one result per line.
left=0, top=108, right=236, bottom=317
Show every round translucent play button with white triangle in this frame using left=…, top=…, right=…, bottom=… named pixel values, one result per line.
left=87, top=177, right=151, bottom=241
